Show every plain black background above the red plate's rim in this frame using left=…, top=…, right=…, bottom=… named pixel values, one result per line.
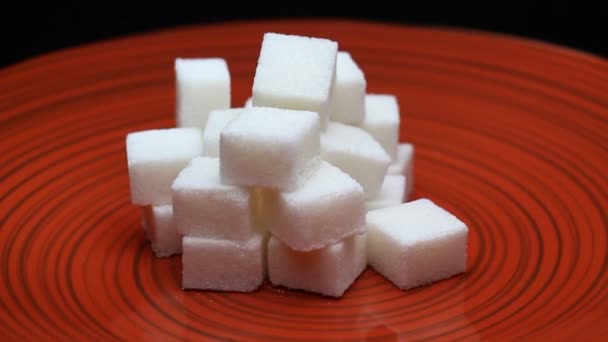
left=0, top=0, right=608, bottom=67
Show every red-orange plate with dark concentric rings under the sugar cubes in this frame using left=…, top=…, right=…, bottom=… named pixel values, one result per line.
left=0, top=21, right=608, bottom=341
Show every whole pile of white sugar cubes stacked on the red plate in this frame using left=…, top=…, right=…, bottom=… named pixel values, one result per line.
left=126, top=33, right=468, bottom=297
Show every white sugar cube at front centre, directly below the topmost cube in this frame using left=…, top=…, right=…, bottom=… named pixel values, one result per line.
left=220, top=107, right=320, bottom=190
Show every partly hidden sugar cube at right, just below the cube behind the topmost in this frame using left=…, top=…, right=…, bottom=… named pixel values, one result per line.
left=361, top=94, right=400, bottom=160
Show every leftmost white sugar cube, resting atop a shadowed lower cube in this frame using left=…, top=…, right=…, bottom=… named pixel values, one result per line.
left=126, top=128, right=203, bottom=205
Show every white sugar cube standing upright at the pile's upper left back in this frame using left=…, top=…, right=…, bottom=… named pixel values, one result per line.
left=175, top=58, right=230, bottom=129
